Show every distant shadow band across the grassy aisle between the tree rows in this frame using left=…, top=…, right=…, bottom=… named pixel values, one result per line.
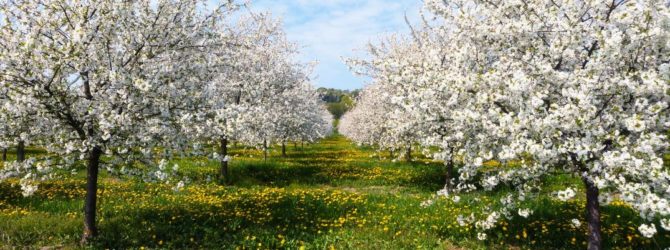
left=223, top=157, right=445, bottom=191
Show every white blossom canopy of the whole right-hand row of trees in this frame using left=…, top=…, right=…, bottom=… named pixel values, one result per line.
left=341, top=0, right=670, bottom=246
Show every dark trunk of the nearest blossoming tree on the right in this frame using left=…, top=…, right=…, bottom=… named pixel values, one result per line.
left=582, top=178, right=603, bottom=250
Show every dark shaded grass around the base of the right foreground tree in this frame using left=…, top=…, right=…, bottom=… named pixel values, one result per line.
left=436, top=197, right=670, bottom=249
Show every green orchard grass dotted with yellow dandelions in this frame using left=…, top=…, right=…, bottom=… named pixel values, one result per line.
left=0, top=135, right=670, bottom=249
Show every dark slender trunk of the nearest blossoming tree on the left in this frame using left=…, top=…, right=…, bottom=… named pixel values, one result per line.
left=81, top=146, right=102, bottom=244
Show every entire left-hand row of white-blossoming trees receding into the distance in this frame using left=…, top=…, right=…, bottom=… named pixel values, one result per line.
left=0, top=0, right=332, bottom=242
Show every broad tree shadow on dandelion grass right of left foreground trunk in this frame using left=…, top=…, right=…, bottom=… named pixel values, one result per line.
left=96, top=190, right=363, bottom=249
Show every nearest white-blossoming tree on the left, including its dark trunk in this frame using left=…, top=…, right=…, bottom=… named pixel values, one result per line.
left=0, top=0, right=240, bottom=242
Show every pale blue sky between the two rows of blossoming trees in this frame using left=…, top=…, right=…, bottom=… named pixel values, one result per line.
left=234, top=0, right=422, bottom=89
